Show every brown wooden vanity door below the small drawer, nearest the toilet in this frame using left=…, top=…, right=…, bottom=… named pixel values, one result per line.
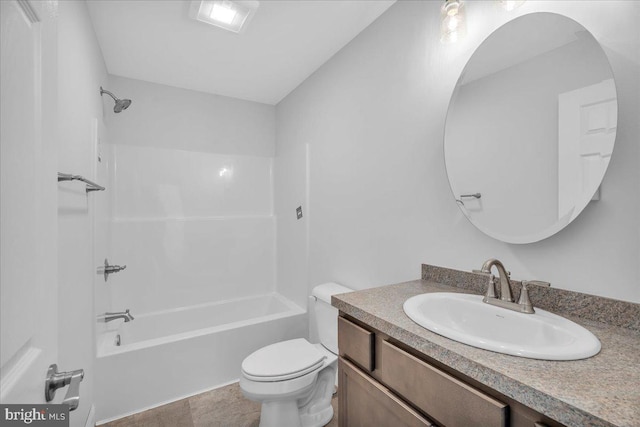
left=338, top=357, right=435, bottom=427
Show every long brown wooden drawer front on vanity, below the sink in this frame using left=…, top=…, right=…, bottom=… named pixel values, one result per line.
left=376, top=340, right=508, bottom=427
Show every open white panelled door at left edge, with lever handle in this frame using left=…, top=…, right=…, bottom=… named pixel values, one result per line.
left=0, top=0, right=59, bottom=404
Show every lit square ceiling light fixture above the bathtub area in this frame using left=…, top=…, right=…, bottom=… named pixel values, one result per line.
left=189, top=0, right=259, bottom=33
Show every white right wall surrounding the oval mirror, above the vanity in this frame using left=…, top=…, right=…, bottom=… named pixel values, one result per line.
left=275, top=1, right=640, bottom=302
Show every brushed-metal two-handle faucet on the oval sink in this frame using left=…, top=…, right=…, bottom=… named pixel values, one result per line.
left=474, top=258, right=551, bottom=314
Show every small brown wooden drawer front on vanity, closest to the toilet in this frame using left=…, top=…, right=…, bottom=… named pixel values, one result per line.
left=338, top=317, right=375, bottom=372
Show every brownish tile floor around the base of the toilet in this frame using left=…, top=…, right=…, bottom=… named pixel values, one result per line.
left=100, top=383, right=338, bottom=427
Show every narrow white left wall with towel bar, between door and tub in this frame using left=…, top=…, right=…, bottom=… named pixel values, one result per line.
left=57, top=1, right=107, bottom=427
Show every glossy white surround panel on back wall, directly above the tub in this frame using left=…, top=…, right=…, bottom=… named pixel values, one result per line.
left=108, top=144, right=276, bottom=315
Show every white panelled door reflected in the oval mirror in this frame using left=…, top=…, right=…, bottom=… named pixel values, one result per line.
left=558, top=79, right=618, bottom=222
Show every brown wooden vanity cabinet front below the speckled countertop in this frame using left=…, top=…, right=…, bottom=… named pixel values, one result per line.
left=338, top=313, right=563, bottom=427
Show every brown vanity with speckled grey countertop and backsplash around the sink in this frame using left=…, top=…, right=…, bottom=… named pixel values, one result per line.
left=332, top=266, right=640, bottom=427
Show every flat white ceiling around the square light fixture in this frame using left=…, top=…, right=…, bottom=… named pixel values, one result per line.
left=87, top=0, right=395, bottom=105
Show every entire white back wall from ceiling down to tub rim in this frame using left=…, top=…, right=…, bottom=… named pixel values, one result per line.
left=105, top=76, right=276, bottom=316
